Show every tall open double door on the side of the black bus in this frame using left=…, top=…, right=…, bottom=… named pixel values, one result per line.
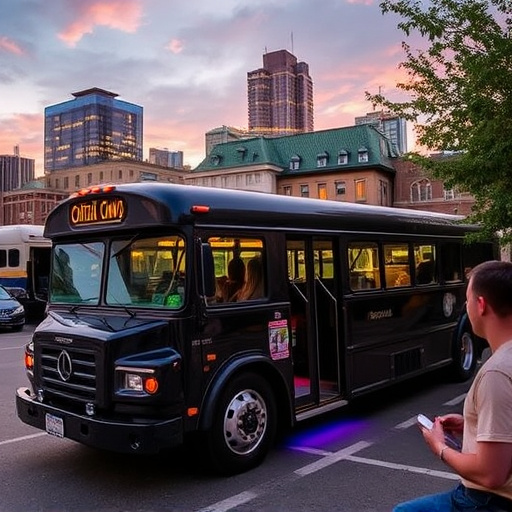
left=287, top=237, right=343, bottom=408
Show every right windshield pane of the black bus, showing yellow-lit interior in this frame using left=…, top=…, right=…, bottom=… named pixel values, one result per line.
left=106, top=236, right=185, bottom=308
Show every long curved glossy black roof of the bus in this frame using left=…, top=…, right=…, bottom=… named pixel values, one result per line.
left=45, top=183, right=478, bottom=238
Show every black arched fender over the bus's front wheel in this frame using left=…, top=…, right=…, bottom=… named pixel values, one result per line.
left=198, top=354, right=292, bottom=431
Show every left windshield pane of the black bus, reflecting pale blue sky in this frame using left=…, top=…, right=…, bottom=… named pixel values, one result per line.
left=50, top=242, right=104, bottom=304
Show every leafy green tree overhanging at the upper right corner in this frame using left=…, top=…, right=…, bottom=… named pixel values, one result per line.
left=366, top=0, right=512, bottom=241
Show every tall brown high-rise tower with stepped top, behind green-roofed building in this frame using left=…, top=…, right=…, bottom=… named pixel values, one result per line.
left=247, top=50, right=314, bottom=136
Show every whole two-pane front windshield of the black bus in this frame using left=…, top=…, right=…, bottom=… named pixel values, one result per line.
left=50, top=236, right=185, bottom=308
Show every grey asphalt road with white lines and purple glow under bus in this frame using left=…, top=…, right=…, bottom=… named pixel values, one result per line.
left=0, top=326, right=469, bottom=512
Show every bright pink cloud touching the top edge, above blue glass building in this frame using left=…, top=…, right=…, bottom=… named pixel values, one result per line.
left=58, top=0, right=142, bottom=47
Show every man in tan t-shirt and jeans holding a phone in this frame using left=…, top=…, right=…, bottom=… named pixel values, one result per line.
left=394, top=261, right=512, bottom=512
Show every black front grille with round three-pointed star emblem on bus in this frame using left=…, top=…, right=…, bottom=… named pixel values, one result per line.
left=41, top=347, right=96, bottom=402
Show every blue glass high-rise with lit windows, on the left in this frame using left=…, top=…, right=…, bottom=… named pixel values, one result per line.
left=44, top=87, right=142, bottom=172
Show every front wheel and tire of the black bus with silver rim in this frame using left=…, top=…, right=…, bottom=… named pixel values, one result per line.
left=207, top=373, right=277, bottom=474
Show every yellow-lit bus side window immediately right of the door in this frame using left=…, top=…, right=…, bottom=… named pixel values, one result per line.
left=348, top=242, right=380, bottom=291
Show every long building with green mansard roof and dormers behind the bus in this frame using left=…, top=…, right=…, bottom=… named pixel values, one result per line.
left=185, top=125, right=399, bottom=206
